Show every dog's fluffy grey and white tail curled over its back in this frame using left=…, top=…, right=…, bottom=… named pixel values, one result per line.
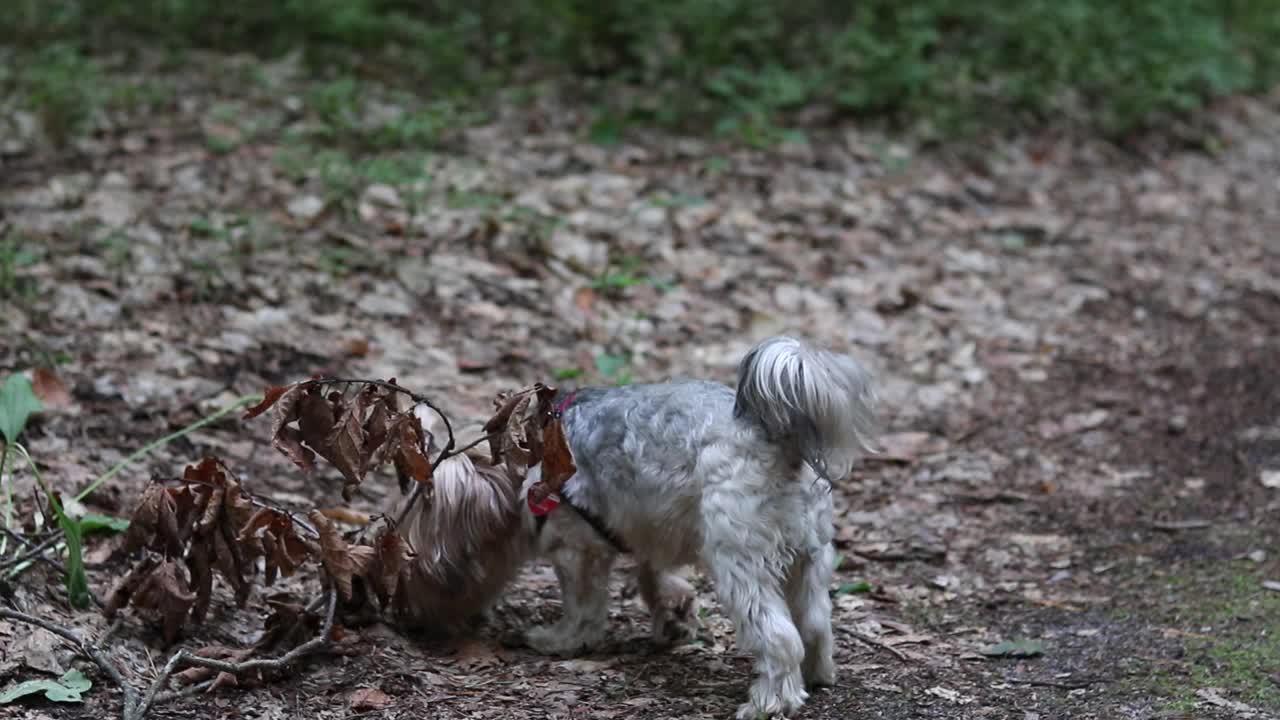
left=733, top=337, right=877, bottom=480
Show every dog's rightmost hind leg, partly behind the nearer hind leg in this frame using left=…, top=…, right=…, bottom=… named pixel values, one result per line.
left=786, top=544, right=836, bottom=688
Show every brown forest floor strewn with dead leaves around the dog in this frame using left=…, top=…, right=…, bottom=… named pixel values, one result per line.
left=0, top=64, right=1280, bottom=720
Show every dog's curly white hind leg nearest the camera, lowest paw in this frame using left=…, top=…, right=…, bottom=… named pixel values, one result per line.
left=710, top=546, right=809, bottom=720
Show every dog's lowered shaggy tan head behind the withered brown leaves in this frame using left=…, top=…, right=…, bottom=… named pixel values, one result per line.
left=393, top=445, right=532, bottom=633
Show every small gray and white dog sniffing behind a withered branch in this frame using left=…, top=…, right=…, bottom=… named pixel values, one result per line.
left=403, top=337, right=876, bottom=719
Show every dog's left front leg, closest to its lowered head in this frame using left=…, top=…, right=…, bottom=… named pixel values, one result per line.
left=525, top=540, right=614, bottom=655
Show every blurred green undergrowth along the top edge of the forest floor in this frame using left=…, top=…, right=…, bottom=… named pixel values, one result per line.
left=0, top=0, right=1280, bottom=142
